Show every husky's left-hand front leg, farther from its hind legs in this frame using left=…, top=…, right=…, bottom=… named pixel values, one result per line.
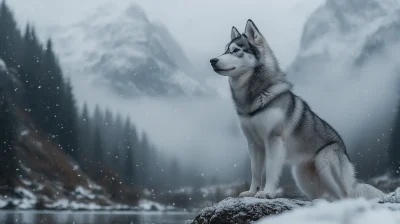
left=239, top=143, right=265, bottom=197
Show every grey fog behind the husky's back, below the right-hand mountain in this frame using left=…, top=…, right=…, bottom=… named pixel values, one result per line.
left=294, top=50, right=400, bottom=151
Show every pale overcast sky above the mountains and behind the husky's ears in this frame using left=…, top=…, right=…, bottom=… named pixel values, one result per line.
left=7, top=0, right=324, bottom=67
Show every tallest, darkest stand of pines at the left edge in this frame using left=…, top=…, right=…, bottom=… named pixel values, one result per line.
left=0, top=0, right=85, bottom=180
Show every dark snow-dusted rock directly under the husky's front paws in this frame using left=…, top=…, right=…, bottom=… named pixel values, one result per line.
left=192, top=198, right=310, bottom=224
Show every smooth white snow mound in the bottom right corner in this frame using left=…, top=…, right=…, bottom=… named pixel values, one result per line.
left=256, top=199, right=400, bottom=224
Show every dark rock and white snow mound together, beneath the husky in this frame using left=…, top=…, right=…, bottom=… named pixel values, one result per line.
left=192, top=195, right=400, bottom=224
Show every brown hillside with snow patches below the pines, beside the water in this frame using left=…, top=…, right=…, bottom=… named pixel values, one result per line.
left=0, top=60, right=119, bottom=209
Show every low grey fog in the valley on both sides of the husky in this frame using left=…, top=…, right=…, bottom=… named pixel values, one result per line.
left=69, top=44, right=400, bottom=179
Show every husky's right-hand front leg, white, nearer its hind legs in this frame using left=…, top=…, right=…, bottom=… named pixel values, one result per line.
left=255, top=136, right=286, bottom=198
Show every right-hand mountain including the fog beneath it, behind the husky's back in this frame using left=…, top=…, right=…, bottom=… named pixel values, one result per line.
left=287, top=0, right=400, bottom=175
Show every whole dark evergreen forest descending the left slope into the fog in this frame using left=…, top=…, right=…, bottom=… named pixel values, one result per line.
left=0, top=0, right=212, bottom=194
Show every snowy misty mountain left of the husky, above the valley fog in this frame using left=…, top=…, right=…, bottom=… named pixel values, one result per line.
left=50, top=3, right=206, bottom=97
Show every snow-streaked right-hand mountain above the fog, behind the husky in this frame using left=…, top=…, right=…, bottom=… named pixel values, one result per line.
left=288, top=0, right=400, bottom=82
